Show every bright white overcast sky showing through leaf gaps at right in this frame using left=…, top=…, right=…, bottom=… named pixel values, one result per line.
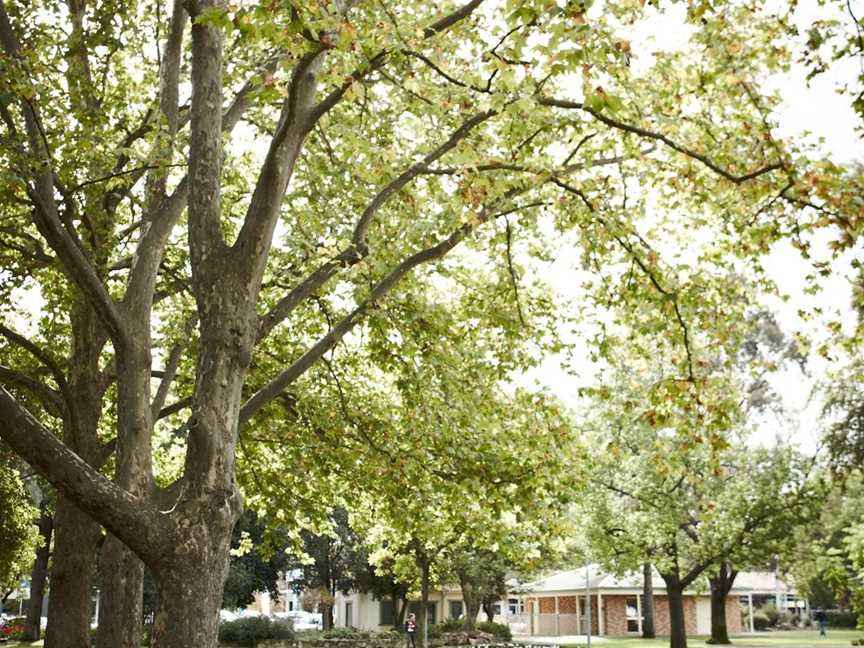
left=525, top=0, right=864, bottom=451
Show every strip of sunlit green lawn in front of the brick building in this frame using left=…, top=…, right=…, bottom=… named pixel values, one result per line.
left=562, top=629, right=864, bottom=648
